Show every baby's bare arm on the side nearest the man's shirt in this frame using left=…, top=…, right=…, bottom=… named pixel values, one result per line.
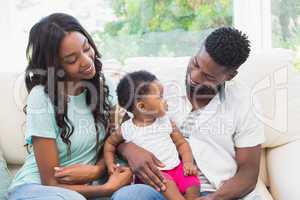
left=171, top=123, right=197, bottom=175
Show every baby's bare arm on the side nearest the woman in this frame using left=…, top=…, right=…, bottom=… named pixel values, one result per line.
left=104, top=129, right=124, bottom=174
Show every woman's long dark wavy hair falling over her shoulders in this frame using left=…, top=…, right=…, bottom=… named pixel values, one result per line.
left=24, top=13, right=111, bottom=155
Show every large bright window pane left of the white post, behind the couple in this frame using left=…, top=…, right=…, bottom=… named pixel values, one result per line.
left=1, top=0, right=233, bottom=71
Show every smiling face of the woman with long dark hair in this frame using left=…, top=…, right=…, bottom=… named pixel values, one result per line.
left=59, top=32, right=96, bottom=82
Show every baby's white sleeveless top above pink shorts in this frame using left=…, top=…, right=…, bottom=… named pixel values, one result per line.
left=121, top=115, right=180, bottom=170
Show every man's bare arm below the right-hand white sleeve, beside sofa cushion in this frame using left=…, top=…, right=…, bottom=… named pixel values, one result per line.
left=200, top=145, right=261, bottom=200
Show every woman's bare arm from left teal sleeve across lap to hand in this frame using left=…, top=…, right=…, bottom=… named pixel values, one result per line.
left=32, top=137, right=130, bottom=197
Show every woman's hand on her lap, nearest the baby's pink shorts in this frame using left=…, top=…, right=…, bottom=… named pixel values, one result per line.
left=105, top=167, right=133, bottom=192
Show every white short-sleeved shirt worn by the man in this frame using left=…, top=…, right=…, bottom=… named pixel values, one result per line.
left=172, top=83, right=264, bottom=199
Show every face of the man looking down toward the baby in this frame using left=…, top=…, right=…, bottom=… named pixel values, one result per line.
left=186, top=48, right=237, bottom=104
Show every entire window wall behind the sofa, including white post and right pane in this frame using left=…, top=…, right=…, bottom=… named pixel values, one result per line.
left=0, top=0, right=300, bottom=71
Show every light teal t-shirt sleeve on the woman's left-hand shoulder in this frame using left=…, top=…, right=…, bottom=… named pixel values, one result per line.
left=25, top=86, right=58, bottom=144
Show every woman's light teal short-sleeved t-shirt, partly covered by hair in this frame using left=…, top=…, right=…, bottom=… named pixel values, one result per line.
left=9, top=81, right=116, bottom=190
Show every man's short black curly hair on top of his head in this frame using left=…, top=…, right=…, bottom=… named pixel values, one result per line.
left=204, top=27, right=250, bottom=69
